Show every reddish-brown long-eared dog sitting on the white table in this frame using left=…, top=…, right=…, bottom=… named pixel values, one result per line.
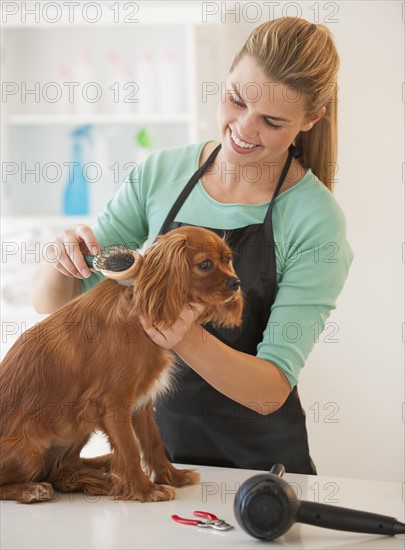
left=0, top=227, right=243, bottom=503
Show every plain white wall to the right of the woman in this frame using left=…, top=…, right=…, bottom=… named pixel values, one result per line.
left=300, top=2, right=405, bottom=481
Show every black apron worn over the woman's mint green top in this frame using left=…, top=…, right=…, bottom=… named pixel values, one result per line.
left=155, top=145, right=316, bottom=474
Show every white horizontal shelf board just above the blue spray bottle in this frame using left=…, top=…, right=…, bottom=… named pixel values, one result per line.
left=7, top=113, right=190, bottom=126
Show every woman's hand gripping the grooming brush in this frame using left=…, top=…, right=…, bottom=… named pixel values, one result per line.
left=51, top=224, right=100, bottom=279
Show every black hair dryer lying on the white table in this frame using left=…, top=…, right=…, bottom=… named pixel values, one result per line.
left=234, top=464, right=405, bottom=540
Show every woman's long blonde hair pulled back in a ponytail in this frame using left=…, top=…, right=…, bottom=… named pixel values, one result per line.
left=230, top=17, right=339, bottom=190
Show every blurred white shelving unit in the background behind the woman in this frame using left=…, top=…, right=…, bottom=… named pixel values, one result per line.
left=1, top=0, right=202, bottom=221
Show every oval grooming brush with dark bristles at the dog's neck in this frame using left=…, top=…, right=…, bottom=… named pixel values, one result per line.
left=83, top=244, right=142, bottom=281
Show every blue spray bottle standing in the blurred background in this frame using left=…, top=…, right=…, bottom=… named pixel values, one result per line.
left=63, top=124, right=91, bottom=216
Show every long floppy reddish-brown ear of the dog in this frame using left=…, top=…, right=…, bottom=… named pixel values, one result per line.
left=133, top=234, right=190, bottom=329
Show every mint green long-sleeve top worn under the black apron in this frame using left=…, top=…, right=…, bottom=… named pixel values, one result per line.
left=82, top=142, right=353, bottom=388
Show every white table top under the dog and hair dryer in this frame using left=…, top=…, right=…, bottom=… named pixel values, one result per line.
left=0, top=466, right=405, bottom=550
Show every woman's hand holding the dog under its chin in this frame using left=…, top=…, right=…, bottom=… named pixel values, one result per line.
left=139, top=303, right=203, bottom=350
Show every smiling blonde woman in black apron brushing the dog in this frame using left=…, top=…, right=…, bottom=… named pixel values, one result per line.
left=32, top=17, right=352, bottom=474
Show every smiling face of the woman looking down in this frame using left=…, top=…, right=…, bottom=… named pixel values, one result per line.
left=217, top=55, right=325, bottom=165
